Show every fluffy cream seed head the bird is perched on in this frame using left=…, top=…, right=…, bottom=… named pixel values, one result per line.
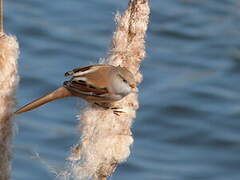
left=66, top=0, right=150, bottom=180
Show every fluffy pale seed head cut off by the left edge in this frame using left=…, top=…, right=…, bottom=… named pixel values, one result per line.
left=0, top=35, right=18, bottom=180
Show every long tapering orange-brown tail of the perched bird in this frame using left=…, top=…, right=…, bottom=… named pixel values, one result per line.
left=15, top=87, right=72, bottom=114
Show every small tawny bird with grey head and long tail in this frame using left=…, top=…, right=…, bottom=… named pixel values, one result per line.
left=15, top=64, right=136, bottom=114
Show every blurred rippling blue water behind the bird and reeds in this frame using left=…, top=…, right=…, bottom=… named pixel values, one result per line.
left=5, top=0, right=240, bottom=180
